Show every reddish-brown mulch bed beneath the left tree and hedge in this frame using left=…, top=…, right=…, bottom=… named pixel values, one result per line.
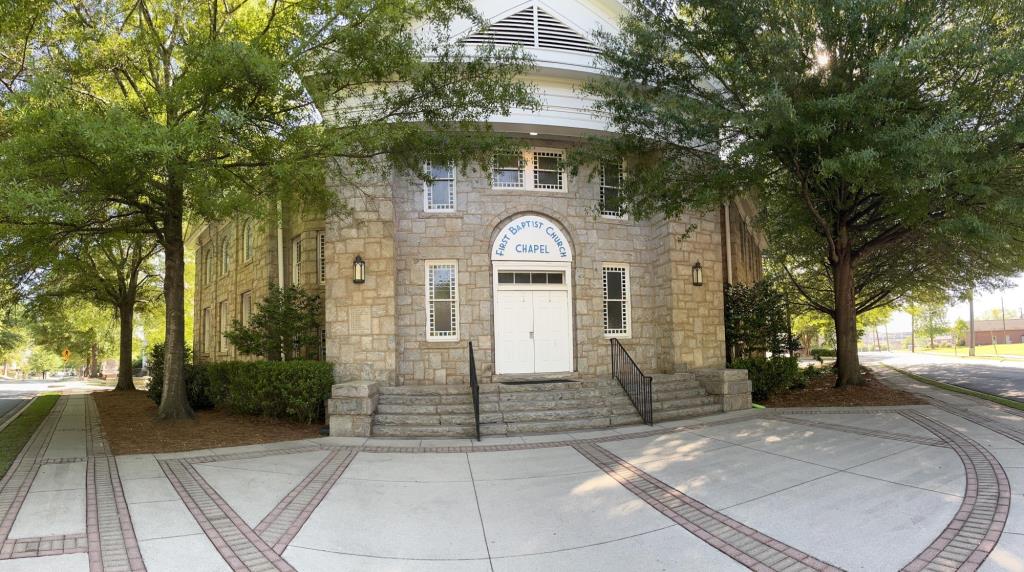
left=92, top=391, right=321, bottom=454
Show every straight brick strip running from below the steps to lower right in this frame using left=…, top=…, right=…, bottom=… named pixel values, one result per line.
left=574, top=444, right=839, bottom=572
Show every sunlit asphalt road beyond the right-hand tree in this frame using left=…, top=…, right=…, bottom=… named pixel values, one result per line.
left=860, top=352, right=1024, bottom=402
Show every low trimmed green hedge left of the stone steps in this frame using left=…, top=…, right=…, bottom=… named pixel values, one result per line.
left=203, top=360, right=334, bottom=423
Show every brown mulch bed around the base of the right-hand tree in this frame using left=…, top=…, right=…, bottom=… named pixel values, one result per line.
left=761, top=368, right=926, bottom=407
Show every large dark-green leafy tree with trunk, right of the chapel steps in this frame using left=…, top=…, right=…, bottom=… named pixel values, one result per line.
left=588, top=0, right=1024, bottom=385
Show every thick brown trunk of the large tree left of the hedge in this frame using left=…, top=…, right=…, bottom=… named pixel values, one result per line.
left=159, top=184, right=193, bottom=420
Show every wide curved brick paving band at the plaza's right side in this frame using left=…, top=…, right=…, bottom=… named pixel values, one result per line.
left=903, top=411, right=1010, bottom=572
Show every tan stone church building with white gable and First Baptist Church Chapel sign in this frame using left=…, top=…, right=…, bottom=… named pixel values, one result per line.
left=191, top=0, right=763, bottom=436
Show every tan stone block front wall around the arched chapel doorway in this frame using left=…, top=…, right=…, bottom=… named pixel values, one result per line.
left=319, top=141, right=737, bottom=385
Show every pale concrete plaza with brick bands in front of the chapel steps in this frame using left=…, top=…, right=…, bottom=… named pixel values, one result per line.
left=0, top=372, right=1024, bottom=572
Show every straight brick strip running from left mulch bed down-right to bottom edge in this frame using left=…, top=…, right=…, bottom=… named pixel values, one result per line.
left=160, top=459, right=294, bottom=572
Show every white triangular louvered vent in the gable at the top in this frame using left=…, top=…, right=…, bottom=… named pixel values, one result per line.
left=462, top=6, right=598, bottom=53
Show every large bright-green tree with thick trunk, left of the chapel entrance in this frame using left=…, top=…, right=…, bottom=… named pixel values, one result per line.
left=0, top=0, right=534, bottom=417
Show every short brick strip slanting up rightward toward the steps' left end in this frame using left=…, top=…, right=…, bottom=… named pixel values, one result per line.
left=256, top=450, right=356, bottom=554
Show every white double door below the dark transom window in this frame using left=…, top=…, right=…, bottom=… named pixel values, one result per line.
left=495, top=289, right=572, bottom=373
